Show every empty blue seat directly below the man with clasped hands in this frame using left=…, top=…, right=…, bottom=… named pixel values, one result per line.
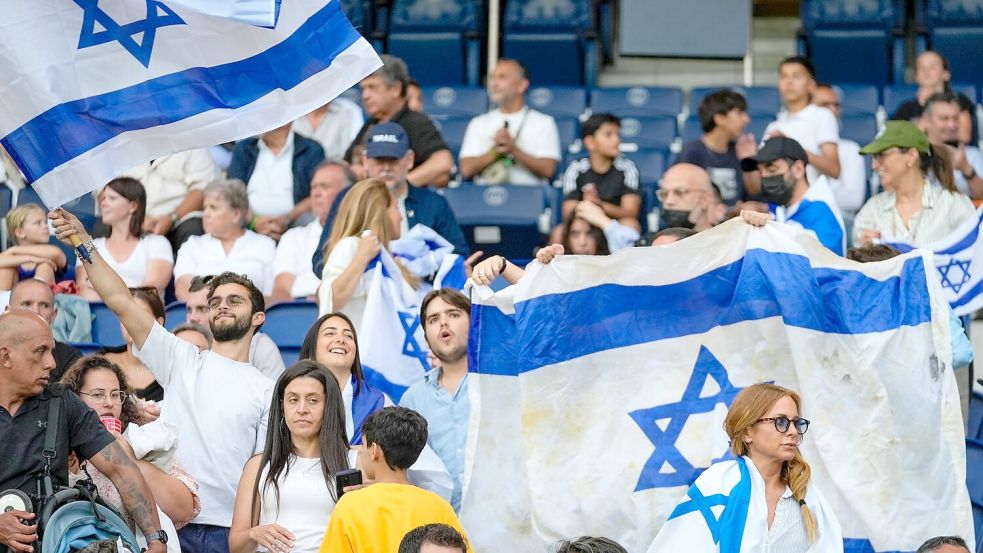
left=442, top=184, right=551, bottom=259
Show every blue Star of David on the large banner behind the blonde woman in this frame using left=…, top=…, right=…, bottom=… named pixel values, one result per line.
left=628, top=346, right=743, bottom=492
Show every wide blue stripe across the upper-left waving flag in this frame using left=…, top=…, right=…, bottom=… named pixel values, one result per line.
left=0, top=0, right=360, bottom=182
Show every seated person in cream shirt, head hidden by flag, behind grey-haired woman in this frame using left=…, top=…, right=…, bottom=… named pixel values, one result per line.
left=121, top=148, right=219, bottom=252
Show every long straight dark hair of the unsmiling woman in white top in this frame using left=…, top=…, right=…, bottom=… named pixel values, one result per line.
left=251, top=360, right=348, bottom=526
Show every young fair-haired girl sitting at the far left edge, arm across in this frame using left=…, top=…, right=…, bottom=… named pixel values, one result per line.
left=0, top=204, right=68, bottom=290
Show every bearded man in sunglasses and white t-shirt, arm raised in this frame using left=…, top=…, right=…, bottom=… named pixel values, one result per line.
left=48, top=209, right=273, bottom=552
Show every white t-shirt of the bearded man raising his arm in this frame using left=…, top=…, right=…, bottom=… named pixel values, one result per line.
left=134, top=323, right=274, bottom=528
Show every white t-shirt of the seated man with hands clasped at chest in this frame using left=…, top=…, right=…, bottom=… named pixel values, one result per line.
left=461, top=107, right=560, bottom=185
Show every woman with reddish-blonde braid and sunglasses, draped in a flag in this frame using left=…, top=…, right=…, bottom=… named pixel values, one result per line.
left=649, top=383, right=843, bottom=553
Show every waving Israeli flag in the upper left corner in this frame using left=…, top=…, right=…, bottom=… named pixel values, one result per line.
left=0, top=0, right=381, bottom=206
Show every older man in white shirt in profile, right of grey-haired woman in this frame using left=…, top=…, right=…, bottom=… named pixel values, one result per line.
left=273, top=161, right=355, bottom=301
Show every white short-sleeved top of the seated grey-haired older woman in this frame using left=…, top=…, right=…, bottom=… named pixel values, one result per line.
left=174, top=230, right=276, bottom=295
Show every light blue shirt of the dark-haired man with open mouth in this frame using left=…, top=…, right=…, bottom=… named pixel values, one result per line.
left=399, top=369, right=471, bottom=511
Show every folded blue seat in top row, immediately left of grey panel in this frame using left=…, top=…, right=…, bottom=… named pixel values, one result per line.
left=502, top=0, right=597, bottom=88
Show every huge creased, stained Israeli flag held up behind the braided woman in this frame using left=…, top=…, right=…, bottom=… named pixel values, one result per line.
left=462, top=220, right=978, bottom=552
